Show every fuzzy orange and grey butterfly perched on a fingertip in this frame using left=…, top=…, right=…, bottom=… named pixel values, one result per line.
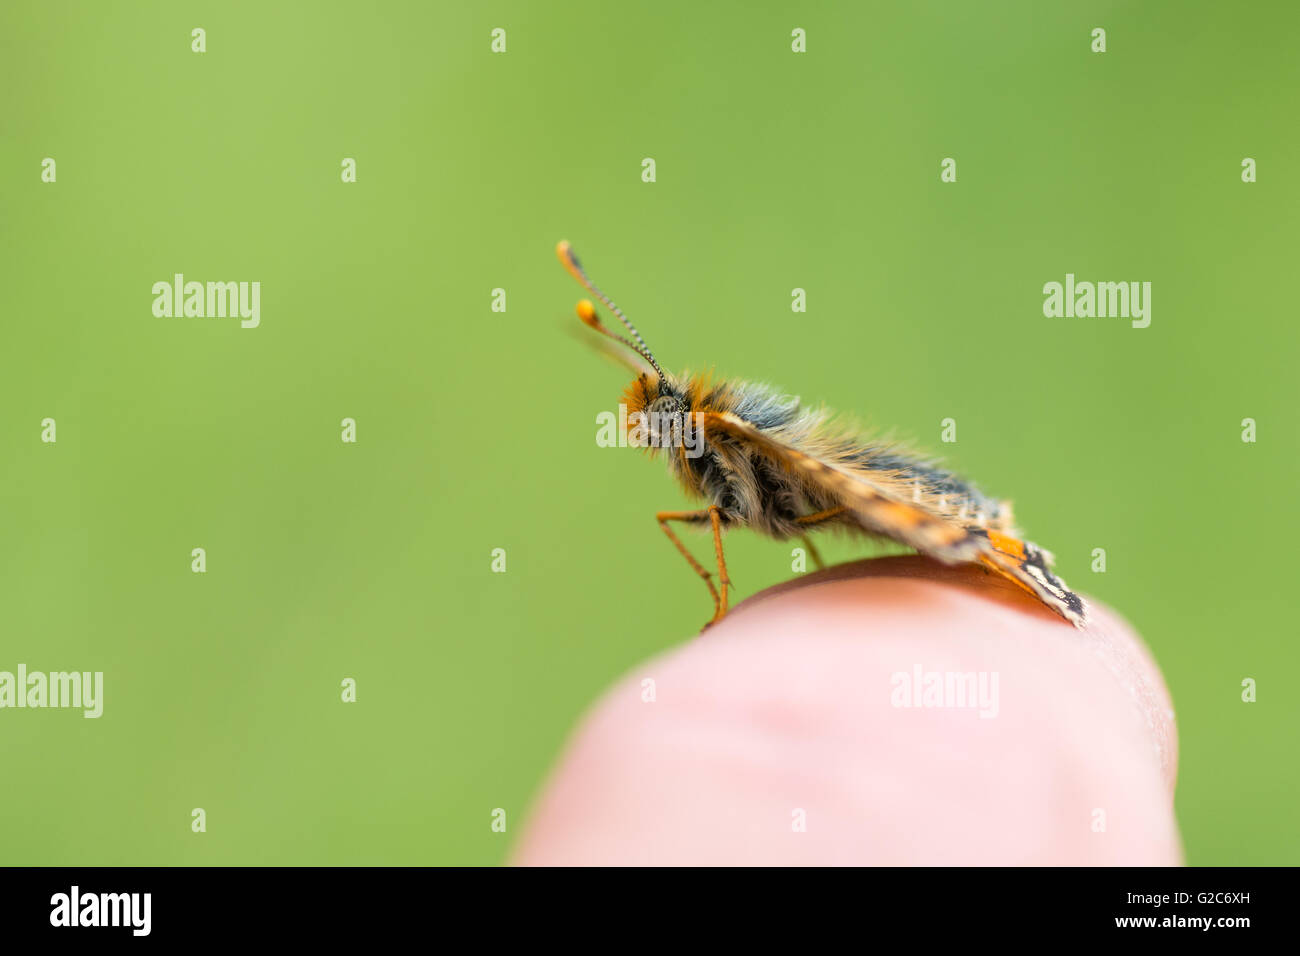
left=555, top=242, right=1087, bottom=627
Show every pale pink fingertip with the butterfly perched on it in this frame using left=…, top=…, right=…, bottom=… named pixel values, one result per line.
left=512, top=557, right=1182, bottom=865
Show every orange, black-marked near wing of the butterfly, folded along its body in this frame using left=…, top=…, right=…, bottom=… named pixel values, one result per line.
left=697, top=412, right=1087, bottom=627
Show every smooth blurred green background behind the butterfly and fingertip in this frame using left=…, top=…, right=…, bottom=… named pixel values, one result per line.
left=0, top=0, right=1300, bottom=864
